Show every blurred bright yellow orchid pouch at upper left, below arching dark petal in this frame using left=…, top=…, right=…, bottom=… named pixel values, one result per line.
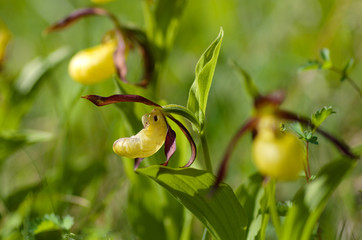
left=68, top=40, right=117, bottom=84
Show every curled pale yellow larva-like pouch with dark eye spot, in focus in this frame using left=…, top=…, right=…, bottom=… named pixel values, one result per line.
left=113, top=109, right=167, bottom=158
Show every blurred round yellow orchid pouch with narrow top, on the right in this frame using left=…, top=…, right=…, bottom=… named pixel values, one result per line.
left=252, top=116, right=305, bottom=181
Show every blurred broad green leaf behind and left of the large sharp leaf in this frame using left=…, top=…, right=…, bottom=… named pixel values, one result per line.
left=127, top=174, right=184, bottom=240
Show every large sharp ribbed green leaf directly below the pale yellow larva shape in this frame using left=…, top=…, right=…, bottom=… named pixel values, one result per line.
left=137, top=165, right=247, bottom=240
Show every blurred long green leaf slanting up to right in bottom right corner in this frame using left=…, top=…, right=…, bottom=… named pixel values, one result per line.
left=282, top=159, right=355, bottom=240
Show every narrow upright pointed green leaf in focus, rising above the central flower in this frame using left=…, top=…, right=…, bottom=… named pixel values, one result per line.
left=187, top=28, right=224, bottom=131
